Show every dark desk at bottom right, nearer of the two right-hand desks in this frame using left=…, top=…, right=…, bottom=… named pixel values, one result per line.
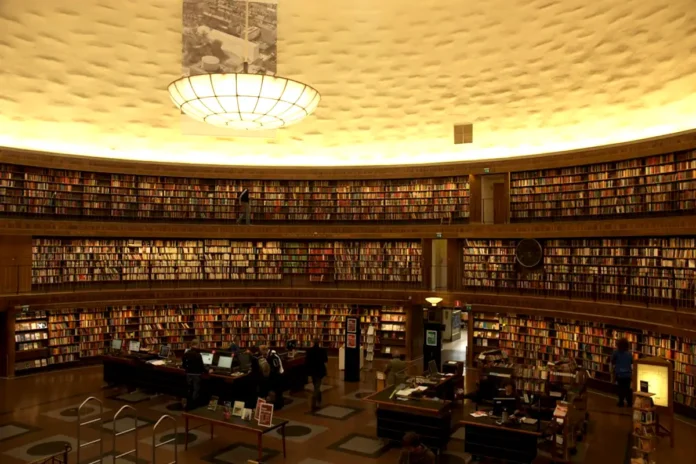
left=458, top=405, right=544, bottom=463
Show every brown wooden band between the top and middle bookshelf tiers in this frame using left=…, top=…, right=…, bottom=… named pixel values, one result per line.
left=0, top=215, right=696, bottom=240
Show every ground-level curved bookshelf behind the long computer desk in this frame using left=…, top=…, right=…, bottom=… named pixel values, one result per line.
left=15, top=303, right=408, bottom=374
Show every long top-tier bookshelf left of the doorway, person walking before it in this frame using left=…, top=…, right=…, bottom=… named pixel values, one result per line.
left=0, top=164, right=469, bottom=222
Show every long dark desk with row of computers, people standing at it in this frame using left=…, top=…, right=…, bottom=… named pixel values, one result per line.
left=103, top=356, right=307, bottom=401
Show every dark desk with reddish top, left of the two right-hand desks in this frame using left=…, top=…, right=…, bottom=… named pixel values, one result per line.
left=364, top=386, right=452, bottom=449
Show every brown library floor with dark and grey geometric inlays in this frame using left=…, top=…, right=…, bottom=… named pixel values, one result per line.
left=0, top=359, right=696, bottom=464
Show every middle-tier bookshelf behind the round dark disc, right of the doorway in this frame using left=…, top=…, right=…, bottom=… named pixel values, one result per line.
left=462, top=237, right=696, bottom=308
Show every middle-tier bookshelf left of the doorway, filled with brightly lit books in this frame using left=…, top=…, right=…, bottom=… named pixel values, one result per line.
left=32, top=238, right=423, bottom=286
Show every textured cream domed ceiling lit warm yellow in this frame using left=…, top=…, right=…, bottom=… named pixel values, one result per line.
left=0, top=0, right=696, bottom=165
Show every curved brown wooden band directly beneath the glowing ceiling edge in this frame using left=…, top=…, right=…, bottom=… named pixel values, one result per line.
left=0, top=130, right=696, bottom=180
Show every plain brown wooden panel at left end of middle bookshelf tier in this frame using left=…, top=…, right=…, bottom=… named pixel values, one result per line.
left=0, top=235, right=32, bottom=295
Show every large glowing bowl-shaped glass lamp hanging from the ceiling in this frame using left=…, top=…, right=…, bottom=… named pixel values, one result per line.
left=168, top=73, right=321, bottom=130
